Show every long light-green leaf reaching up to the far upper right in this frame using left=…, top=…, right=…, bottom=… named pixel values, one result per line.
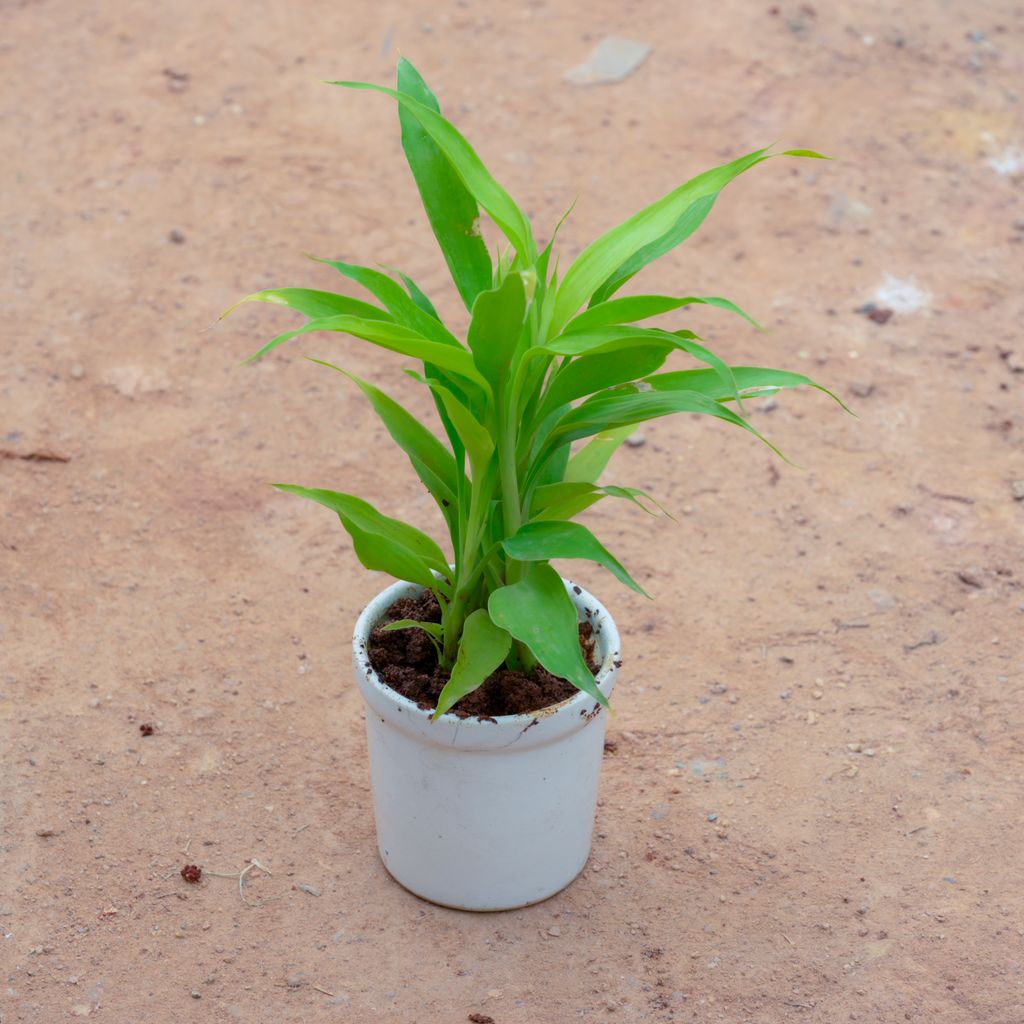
left=552, top=150, right=768, bottom=332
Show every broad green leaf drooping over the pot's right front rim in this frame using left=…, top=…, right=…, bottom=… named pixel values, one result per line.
left=487, top=562, right=608, bottom=708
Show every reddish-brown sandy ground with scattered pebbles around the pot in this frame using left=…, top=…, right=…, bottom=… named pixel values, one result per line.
left=0, top=0, right=1024, bottom=1024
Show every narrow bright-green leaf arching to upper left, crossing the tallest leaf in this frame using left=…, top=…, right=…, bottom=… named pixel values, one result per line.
left=330, top=82, right=537, bottom=259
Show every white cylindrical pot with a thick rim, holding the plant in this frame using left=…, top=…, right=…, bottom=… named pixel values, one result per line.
left=352, top=583, right=620, bottom=910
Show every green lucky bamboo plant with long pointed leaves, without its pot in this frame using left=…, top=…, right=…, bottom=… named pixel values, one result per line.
left=232, top=59, right=843, bottom=717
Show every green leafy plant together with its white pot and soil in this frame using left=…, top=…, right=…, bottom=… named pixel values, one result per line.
left=228, top=60, right=843, bottom=910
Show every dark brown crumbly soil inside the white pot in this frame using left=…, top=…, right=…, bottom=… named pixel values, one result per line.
left=370, top=594, right=598, bottom=718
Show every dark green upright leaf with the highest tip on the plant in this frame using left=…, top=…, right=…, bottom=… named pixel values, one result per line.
left=398, top=57, right=493, bottom=309
